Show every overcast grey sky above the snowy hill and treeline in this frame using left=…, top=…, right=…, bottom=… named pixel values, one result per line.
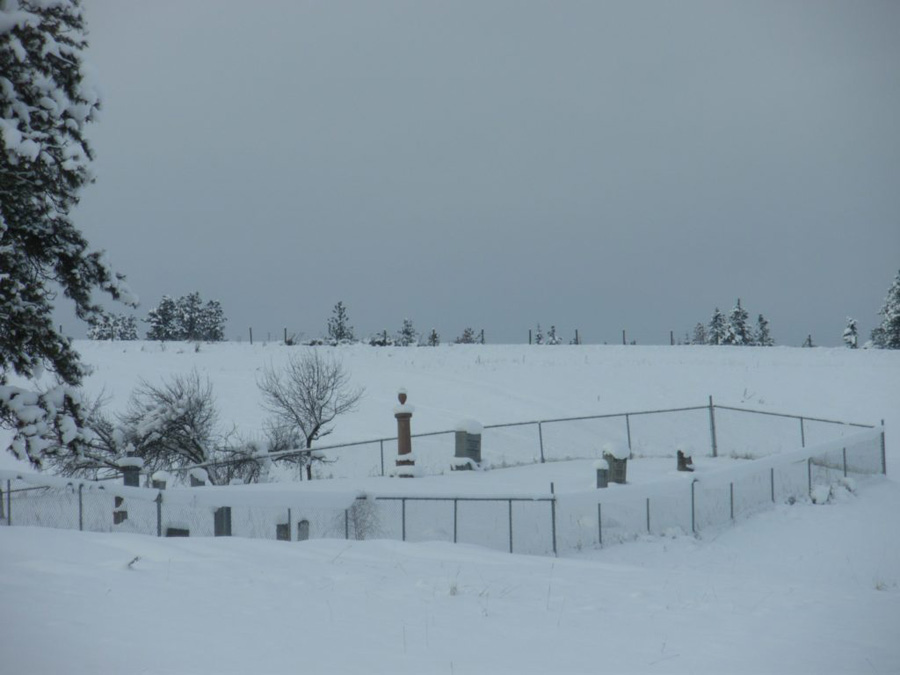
left=67, top=0, right=900, bottom=345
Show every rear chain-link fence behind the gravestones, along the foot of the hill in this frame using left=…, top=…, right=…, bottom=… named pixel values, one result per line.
left=155, top=396, right=874, bottom=484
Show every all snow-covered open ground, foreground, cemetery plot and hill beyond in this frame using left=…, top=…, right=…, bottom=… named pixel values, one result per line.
left=0, top=343, right=900, bottom=673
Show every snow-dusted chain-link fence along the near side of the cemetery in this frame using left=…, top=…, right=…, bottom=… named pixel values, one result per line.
left=0, top=427, right=887, bottom=555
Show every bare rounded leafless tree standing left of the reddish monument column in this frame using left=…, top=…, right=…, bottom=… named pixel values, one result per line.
left=257, top=350, right=364, bottom=479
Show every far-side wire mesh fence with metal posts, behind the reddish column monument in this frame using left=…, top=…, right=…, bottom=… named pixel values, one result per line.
left=173, top=396, right=874, bottom=478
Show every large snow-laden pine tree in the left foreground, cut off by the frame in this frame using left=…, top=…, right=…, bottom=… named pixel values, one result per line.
left=0, top=0, right=137, bottom=466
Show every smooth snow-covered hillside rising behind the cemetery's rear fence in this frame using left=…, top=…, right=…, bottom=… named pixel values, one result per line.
left=10, top=341, right=900, bottom=454
